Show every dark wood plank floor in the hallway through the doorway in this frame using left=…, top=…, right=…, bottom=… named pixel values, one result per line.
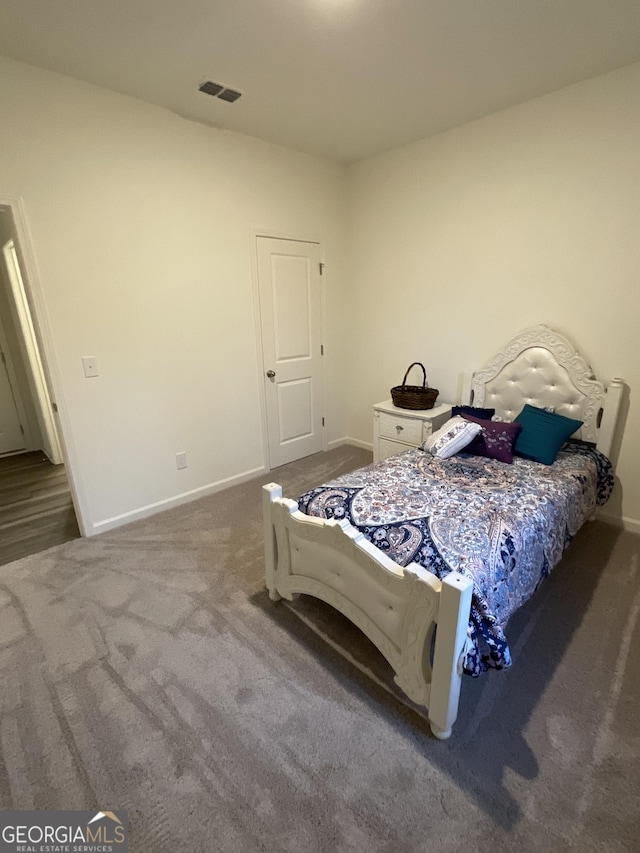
left=0, top=451, right=80, bottom=565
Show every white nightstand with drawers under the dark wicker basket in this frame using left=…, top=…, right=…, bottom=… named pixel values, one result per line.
left=373, top=400, right=451, bottom=462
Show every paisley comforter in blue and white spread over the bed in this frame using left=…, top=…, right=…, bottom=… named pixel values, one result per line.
left=298, top=445, right=613, bottom=675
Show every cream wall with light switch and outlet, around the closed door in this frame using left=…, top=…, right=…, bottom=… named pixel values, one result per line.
left=0, top=53, right=346, bottom=533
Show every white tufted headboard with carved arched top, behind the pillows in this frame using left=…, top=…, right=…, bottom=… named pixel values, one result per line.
left=468, top=325, right=623, bottom=456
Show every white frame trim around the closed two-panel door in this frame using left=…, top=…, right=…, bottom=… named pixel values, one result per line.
left=250, top=228, right=328, bottom=471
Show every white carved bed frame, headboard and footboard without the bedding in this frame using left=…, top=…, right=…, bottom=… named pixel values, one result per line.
left=263, top=326, right=624, bottom=740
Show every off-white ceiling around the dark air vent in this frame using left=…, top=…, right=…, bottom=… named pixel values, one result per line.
left=0, top=0, right=640, bottom=162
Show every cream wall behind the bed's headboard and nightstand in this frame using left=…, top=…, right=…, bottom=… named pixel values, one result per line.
left=349, top=65, right=640, bottom=531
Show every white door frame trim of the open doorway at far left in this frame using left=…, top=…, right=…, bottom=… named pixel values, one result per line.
left=0, top=192, right=91, bottom=536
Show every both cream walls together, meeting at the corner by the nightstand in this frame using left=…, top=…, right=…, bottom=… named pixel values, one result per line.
left=0, top=53, right=640, bottom=533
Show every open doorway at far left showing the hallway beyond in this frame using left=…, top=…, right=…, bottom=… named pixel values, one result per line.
left=0, top=204, right=81, bottom=565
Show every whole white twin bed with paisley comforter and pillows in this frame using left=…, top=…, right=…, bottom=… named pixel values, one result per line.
left=263, top=325, right=624, bottom=739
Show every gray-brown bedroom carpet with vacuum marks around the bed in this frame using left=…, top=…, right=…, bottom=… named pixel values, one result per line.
left=0, top=448, right=640, bottom=853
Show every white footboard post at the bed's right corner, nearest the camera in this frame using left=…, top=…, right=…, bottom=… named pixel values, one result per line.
left=428, top=572, right=473, bottom=740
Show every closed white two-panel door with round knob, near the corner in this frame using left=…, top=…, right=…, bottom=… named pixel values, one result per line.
left=257, top=237, right=323, bottom=468
